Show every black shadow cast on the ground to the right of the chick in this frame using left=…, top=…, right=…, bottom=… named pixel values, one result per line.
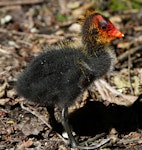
left=69, top=95, right=142, bottom=136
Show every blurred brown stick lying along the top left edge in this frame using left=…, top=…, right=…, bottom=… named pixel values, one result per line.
left=0, top=0, right=44, bottom=6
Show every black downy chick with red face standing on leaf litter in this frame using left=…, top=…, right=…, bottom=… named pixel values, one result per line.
left=16, top=11, right=123, bottom=149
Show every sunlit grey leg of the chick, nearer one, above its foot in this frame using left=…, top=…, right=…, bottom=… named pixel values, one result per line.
left=62, top=107, right=78, bottom=147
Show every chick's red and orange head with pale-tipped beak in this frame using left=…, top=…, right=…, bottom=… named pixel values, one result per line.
left=79, top=11, right=124, bottom=44
